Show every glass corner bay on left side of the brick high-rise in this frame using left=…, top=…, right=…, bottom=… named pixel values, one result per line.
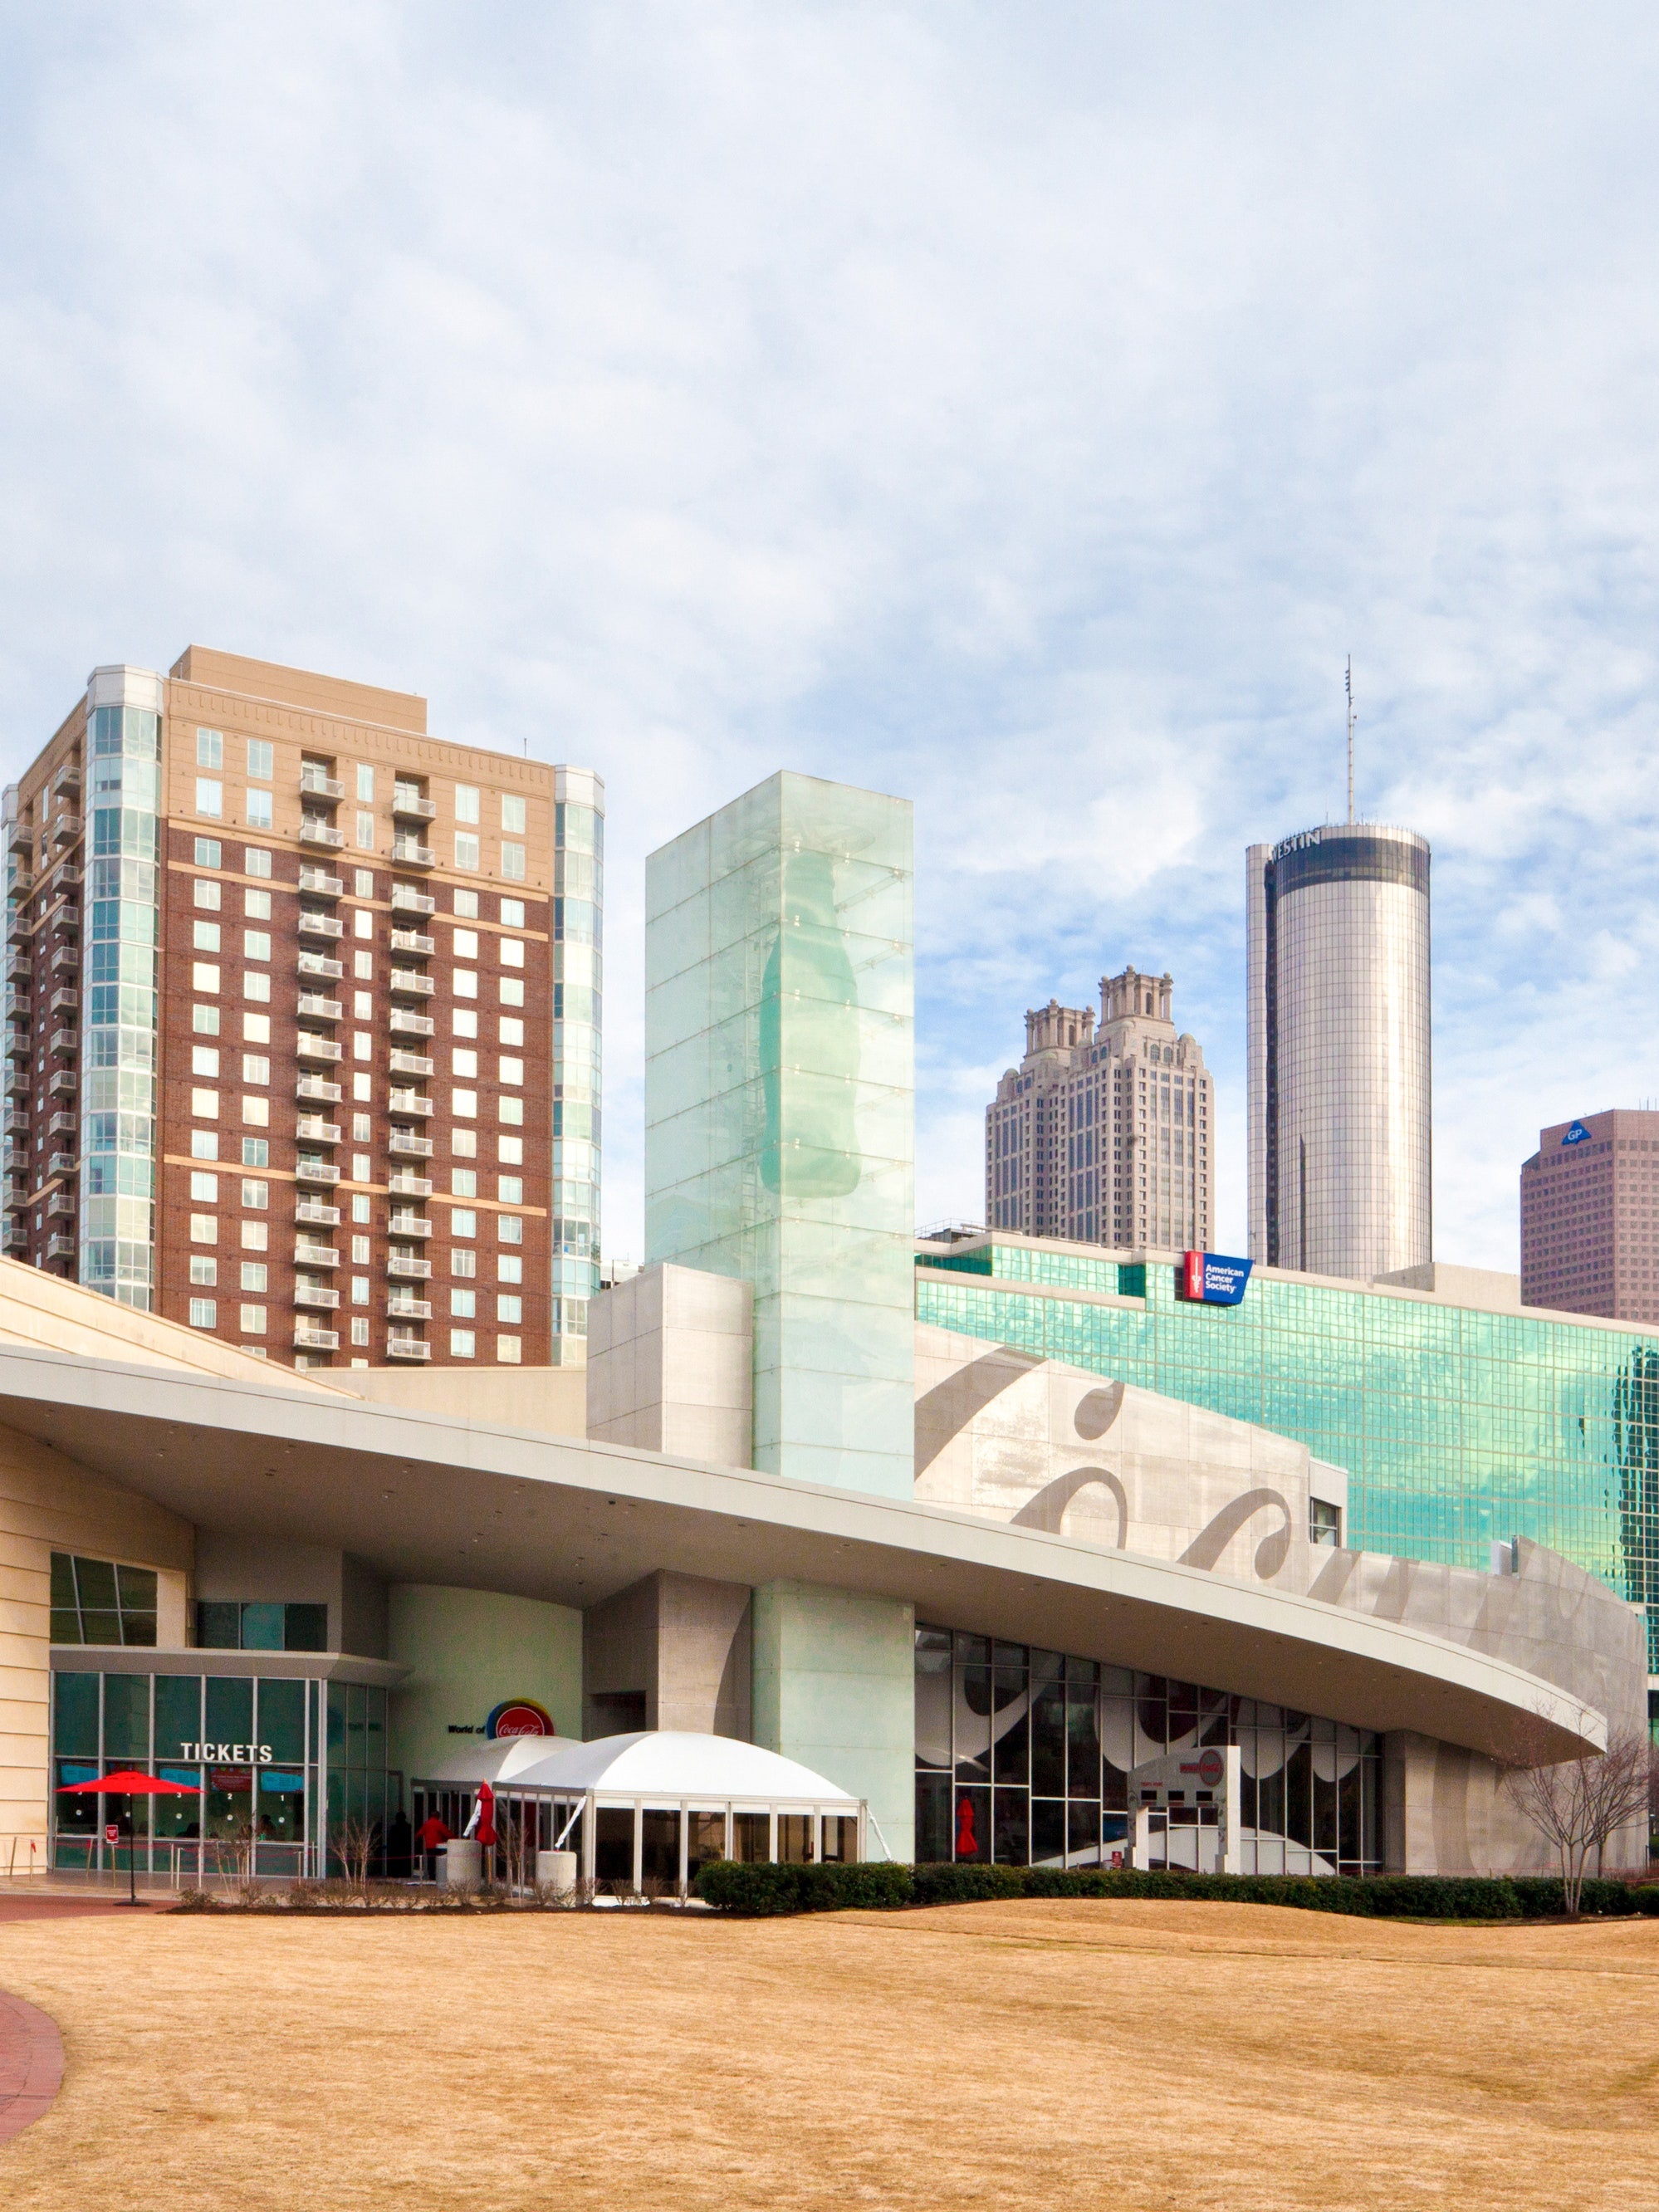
left=80, top=706, right=161, bottom=1309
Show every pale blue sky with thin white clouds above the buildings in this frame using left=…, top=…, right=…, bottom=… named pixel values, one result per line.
left=0, top=0, right=1659, bottom=1267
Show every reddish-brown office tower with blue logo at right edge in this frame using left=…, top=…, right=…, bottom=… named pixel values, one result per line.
left=1522, top=1108, right=1659, bottom=1323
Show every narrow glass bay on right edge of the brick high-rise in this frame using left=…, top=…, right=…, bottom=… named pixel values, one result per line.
left=553, top=767, right=604, bottom=1367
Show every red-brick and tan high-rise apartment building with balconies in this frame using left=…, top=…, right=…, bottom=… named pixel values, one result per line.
left=4, top=646, right=604, bottom=1367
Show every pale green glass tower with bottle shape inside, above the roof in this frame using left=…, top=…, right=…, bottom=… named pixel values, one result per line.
left=646, top=774, right=916, bottom=1498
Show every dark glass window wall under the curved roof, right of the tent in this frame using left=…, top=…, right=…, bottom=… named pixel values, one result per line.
left=916, top=1628, right=1382, bottom=1873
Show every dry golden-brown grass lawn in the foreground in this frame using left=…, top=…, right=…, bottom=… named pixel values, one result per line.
left=0, top=1902, right=1659, bottom=2212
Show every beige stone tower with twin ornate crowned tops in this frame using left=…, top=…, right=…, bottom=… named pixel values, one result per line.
left=984, top=967, right=1215, bottom=1252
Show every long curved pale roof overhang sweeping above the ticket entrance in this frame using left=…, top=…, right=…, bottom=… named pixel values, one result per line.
left=0, top=1345, right=1606, bottom=1759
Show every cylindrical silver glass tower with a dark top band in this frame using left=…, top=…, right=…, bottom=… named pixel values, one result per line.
left=1245, top=823, right=1431, bottom=1283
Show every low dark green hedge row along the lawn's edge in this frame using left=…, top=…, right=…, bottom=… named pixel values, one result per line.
left=697, top=1860, right=1659, bottom=1920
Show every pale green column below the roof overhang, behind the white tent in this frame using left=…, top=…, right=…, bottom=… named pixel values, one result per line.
left=754, top=1582, right=916, bottom=1860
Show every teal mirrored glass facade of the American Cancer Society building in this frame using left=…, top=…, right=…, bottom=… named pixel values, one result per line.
left=916, top=1243, right=1659, bottom=1672
